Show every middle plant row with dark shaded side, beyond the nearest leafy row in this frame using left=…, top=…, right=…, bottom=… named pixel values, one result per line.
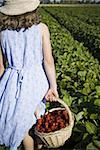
left=44, top=7, right=100, bottom=60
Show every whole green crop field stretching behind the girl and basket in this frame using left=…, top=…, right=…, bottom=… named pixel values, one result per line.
left=0, top=5, right=100, bottom=150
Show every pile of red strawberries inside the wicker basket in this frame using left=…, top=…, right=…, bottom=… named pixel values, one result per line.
left=36, top=109, right=69, bottom=133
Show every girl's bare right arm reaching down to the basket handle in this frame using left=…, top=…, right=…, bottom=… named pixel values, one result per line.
left=42, top=24, right=58, bottom=99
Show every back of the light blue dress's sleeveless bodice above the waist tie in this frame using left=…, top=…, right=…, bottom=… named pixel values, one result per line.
left=1, top=23, right=43, bottom=68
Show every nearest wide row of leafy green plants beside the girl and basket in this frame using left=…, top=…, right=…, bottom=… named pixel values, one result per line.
left=40, top=8, right=100, bottom=150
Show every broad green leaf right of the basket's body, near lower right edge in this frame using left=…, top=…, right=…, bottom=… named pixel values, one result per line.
left=86, top=121, right=97, bottom=134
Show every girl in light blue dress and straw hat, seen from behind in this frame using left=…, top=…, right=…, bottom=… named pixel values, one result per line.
left=0, top=0, right=58, bottom=150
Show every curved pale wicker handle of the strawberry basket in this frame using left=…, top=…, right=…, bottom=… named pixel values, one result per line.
left=52, top=98, right=74, bottom=127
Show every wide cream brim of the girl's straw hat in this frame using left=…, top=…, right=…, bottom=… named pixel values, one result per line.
left=0, top=0, right=40, bottom=15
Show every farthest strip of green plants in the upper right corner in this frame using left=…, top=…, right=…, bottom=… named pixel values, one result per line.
left=57, top=6, right=100, bottom=27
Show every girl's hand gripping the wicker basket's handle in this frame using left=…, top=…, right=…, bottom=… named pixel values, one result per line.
left=45, top=88, right=59, bottom=102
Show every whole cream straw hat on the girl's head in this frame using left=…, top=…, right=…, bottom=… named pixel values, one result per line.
left=0, top=0, right=40, bottom=15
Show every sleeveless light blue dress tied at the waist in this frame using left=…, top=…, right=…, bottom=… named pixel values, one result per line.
left=0, top=23, right=49, bottom=150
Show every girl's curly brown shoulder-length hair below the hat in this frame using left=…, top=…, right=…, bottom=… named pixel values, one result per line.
left=0, top=6, right=41, bottom=31
